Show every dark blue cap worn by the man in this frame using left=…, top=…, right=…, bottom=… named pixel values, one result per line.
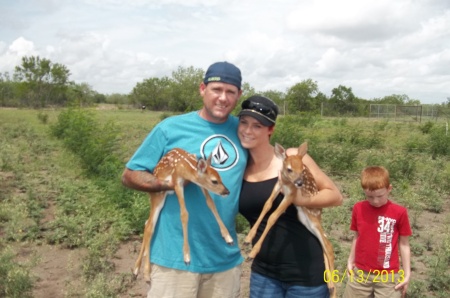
left=203, top=61, right=242, bottom=90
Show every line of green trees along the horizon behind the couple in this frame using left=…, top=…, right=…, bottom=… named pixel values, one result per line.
left=0, top=56, right=450, bottom=115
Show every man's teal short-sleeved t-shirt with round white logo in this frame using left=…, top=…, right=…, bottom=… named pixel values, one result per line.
left=126, top=112, right=247, bottom=273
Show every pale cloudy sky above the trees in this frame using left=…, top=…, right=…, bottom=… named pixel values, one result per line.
left=0, top=0, right=450, bottom=103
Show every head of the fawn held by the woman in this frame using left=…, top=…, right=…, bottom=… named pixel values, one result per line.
left=275, top=142, right=316, bottom=194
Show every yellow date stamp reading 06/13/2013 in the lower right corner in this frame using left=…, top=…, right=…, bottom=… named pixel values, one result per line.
left=323, top=269, right=405, bottom=283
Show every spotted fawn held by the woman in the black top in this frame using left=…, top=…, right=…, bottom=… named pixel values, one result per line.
left=244, top=142, right=336, bottom=297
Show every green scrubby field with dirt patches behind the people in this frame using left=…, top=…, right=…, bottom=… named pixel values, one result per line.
left=0, top=108, right=450, bottom=298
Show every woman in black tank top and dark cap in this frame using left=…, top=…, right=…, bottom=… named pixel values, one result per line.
left=238, top=95, right=342, bottom=298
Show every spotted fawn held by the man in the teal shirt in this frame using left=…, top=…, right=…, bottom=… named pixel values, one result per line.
left=133, top=148, right=233, bottom=283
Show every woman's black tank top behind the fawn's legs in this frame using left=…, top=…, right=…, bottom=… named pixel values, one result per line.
left=239, top=178, right=325, bottom=286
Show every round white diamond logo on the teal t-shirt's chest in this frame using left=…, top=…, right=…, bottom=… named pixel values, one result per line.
left=200, top=135, right=239, bottom=171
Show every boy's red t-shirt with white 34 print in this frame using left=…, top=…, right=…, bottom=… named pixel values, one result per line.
left=350, top=200, right=412, bottom=272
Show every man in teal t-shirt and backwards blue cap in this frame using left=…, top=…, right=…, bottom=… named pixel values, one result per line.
left=122, top=62, right=247, bottom=298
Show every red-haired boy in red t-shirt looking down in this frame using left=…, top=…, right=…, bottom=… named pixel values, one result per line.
left=343, top=166, right=412, bottom=298
